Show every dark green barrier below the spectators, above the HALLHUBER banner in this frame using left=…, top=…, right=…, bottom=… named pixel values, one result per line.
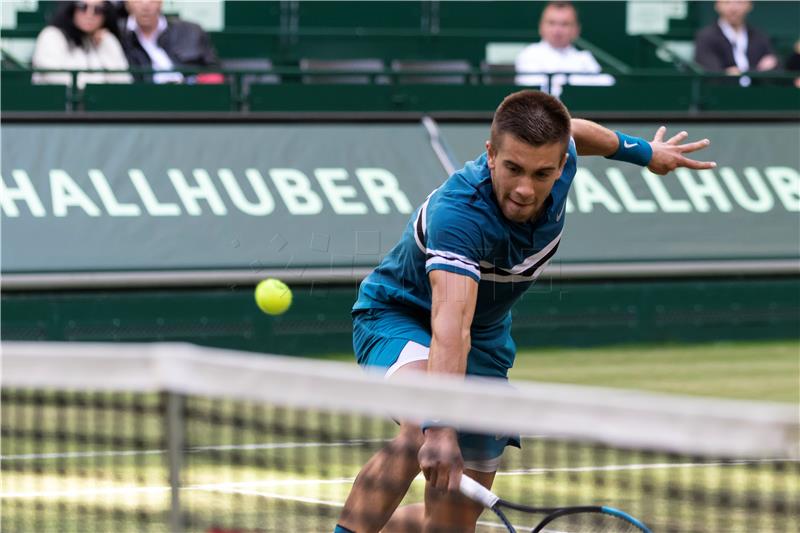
left=2, top=75, right=800, bottom=112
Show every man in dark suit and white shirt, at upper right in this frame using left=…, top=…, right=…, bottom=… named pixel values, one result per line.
left=694, top=0, right=778, bottom=87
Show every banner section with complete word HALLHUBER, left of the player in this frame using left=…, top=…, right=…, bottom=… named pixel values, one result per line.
left=0, top=123, right=445, bottom=272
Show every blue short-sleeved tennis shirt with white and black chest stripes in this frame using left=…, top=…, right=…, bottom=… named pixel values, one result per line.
left=353, top=139, right=577, bottom=329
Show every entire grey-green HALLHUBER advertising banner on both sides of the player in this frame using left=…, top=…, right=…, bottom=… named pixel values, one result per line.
left=0, top=123, right=800, bottom=273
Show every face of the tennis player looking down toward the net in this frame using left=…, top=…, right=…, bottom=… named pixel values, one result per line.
left=486, top=133, right=567, bottom=223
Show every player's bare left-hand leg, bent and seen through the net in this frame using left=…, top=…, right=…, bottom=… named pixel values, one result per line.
left=339, top=361, right=427, bottom=533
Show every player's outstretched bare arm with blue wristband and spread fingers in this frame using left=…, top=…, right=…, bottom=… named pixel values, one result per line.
left=572, top=119, right=717, bottom=175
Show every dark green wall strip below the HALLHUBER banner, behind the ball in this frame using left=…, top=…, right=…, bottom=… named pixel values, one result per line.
left=2, top=277, right=800, bottom=356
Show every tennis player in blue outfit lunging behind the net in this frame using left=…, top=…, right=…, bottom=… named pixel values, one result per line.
left=335, top=90, right=716, bottom=533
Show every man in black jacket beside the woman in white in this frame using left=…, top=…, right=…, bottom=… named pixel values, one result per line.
left=122, top=0, right=221, bottom=83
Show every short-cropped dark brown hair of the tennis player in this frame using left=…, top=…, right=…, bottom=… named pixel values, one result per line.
left=491, top=90, right=572, bottom=151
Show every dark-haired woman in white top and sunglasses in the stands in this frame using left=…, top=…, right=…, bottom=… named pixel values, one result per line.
left=31, top=0, right=131, bottom=88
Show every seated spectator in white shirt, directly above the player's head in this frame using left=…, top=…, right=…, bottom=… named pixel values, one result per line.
left=515, top=2, right=614, bottom=96
